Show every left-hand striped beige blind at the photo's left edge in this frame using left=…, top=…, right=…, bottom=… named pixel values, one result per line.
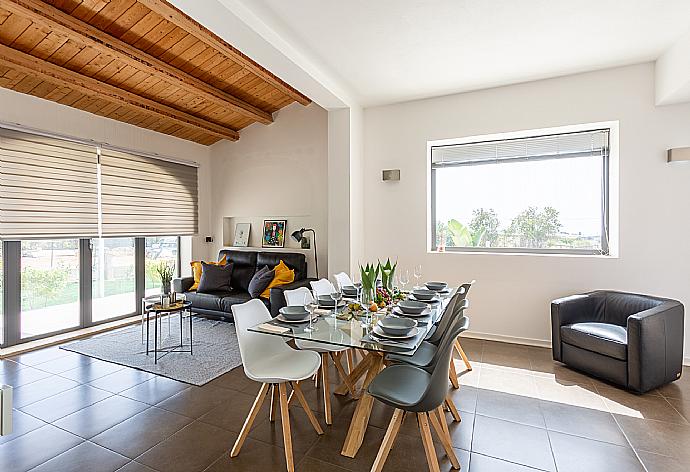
left=0, top=129, right=98, bottom=240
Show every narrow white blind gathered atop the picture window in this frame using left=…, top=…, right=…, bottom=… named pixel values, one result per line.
left=431, top=130, right=609, bottom=168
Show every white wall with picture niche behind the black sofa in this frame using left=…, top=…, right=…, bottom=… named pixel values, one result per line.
left=210, top=103, right=329, bottom=276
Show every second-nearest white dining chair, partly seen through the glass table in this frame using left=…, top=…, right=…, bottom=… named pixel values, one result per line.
left=283, top=287, right=355, bottom=425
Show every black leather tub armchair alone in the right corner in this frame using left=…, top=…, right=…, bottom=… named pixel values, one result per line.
left=551, top=290, right=684, bottom=393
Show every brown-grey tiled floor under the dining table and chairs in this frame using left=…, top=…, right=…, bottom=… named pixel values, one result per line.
left=0, top=339, right=690, bottom=472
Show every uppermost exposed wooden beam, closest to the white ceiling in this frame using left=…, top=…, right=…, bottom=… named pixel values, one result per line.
left=138, top=0, right=311, bottom=105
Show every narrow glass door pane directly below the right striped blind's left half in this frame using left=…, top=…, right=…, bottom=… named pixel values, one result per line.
left=91, top=238, right=137, bottom=322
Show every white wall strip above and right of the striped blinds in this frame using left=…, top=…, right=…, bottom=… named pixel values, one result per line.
left=0, top=88, right=211, bottom=274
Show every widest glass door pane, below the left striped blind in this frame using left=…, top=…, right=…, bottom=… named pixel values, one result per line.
left=20, top=239, right=80, bottom=338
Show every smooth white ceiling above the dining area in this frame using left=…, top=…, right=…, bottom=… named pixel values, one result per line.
left=234, top=0, right=690, bottom=106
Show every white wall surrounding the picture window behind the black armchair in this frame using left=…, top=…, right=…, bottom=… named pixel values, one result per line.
left=364, top=64, right=690, bottom=352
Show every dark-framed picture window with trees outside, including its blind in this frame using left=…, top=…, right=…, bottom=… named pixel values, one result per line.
left=430, top=129, right=609, bottom=254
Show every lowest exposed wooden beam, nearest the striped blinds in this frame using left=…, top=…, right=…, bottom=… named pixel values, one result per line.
left=0, top=45, right=240, bottom=141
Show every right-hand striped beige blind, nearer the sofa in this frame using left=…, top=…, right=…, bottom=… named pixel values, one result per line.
left=100, top=148, right=199, bottom=236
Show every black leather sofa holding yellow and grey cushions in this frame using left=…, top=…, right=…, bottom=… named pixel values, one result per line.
left=173, top=250, right=314, bottom=319
